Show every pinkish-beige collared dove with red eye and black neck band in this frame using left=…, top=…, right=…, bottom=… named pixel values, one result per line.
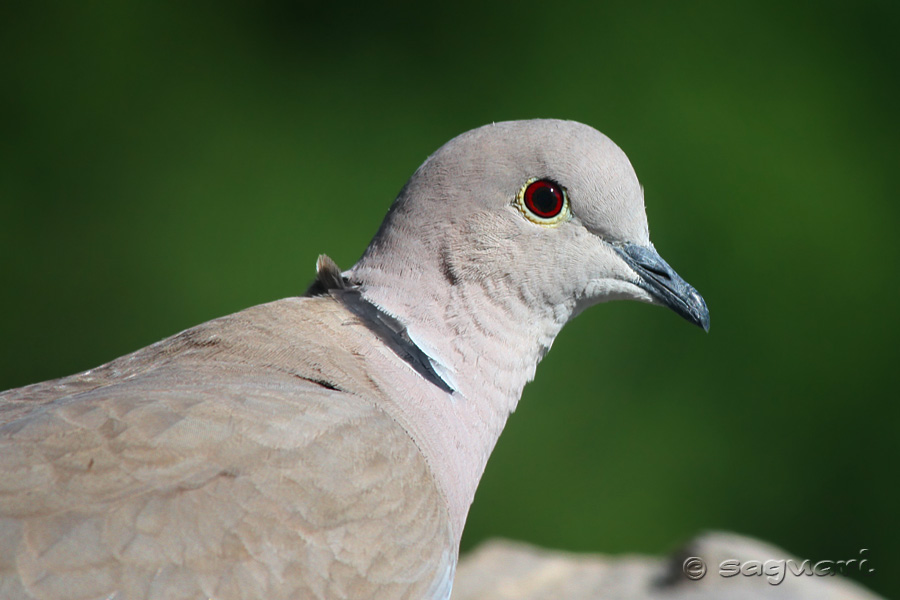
left=0, top=120, right=709, bottom=600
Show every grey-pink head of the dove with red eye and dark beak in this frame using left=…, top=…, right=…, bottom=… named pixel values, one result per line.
left=364, top=119, right=709, bottom=329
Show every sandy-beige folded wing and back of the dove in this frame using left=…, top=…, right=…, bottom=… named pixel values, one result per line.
left=0, top=298, right=456, bottom=600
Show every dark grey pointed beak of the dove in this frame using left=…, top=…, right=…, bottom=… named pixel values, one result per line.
left=614, top=244, right=709, bottom=331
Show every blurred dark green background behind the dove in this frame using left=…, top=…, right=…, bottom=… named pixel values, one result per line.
left=0, top=1, right=900, bottom=596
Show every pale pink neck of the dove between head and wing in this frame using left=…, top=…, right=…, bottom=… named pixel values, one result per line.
left=347, top=253, right=572, bottom=535
